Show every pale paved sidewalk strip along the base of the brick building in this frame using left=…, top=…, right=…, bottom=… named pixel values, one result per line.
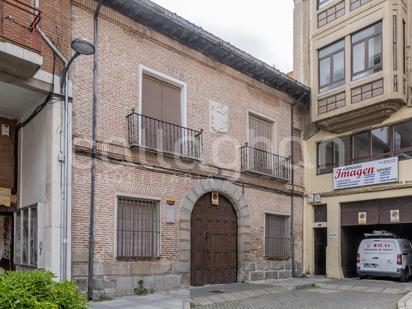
left=93, top=277, right=412, bottom=309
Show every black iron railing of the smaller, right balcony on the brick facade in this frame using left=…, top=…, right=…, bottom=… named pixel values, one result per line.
left=240, top=144, right=291, bottom=181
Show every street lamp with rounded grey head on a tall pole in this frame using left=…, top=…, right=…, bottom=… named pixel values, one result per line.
left=60, top=38, right=95, bottom=281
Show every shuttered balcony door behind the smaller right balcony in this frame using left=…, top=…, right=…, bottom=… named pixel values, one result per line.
left=249, top=115, right=274, bottom=175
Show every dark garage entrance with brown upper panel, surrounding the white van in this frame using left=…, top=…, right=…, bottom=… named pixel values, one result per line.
left=341, top=197, right=412, bottom=278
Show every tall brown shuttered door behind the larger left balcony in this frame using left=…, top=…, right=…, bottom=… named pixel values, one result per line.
left=140, top=74, right=182, bottom=153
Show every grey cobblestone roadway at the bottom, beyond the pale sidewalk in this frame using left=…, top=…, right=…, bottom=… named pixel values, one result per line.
left=196, top=288, right=403, bottom=309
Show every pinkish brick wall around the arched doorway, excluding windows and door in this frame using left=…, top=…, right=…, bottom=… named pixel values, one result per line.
left=72, top=0, right=303, bottom=295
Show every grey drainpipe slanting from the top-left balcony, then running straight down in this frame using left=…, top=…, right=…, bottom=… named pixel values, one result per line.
left=36, top=25, right=69, bottom=281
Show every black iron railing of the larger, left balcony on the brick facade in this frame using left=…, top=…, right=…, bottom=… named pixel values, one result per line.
left=127, top=111, right=203, bottom=160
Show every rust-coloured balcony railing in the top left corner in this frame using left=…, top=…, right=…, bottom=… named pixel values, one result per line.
left=0, top=0, right=41, bottom=53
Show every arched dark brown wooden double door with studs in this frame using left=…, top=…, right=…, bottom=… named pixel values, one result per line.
left=191, top=193, right=237, bottom=286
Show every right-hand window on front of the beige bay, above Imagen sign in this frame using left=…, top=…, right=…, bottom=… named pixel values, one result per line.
left=352, top=22, right=382, bottom=80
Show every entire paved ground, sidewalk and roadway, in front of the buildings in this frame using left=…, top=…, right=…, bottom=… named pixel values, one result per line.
left=93, top=278, right=412, bottom=309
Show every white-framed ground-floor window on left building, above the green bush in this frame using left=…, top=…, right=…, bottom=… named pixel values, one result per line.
left=14, top=204, right=38, bottom=267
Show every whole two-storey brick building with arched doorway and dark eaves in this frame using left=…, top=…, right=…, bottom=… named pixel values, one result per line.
left=71, top=0, right=309, bottom=295
